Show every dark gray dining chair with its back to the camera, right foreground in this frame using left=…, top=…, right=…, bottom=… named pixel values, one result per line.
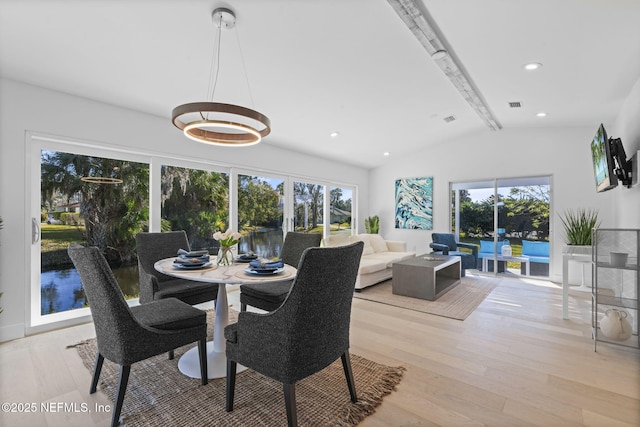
left=224, top=242, right=364, bottom=426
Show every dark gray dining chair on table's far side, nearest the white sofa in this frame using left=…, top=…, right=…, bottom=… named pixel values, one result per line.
left=240, top=231, right=322, bottom=311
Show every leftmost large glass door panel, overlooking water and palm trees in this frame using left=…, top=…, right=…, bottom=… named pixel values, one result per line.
left=30, top=138, right=149, bottom=326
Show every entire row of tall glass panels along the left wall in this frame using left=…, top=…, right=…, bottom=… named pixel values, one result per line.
left=26, top=133, right=356, bottom=327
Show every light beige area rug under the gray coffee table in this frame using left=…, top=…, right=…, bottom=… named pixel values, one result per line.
left=353, top=275, right=502, bottom=320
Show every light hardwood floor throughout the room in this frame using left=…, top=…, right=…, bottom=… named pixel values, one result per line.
left=0, top=278, right=640, bottom=427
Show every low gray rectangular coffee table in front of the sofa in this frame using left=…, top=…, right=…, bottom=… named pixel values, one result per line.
left=391, top=254, right=460, bottom=301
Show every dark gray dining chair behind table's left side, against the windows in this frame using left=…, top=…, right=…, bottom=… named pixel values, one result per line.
left=136, top=234, right=218, bottom=305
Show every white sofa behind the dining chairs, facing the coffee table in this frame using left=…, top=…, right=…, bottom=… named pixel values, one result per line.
left=322, top=234, right=416, bottom=289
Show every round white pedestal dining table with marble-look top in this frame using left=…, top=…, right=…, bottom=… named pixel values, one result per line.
left=154, top=257, right=297, bottom=379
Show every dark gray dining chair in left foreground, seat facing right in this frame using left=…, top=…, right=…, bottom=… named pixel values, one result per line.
left=68, top=245, right=208, bottom=426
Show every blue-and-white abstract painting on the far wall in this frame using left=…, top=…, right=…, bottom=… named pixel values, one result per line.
left=395, top=177, right=433, bottom=230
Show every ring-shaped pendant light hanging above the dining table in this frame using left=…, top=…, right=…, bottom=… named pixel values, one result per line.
left=171, top=8, right=271, bottom=147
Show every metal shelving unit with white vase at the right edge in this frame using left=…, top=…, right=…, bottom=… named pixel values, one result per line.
left=591, top=228, right=640, bottom=351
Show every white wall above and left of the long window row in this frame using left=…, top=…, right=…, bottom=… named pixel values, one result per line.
left=0, top=79, right=369, bottom=341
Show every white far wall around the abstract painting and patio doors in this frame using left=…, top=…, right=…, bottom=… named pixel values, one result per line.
left=364, top=110, right=640, bottom=281
